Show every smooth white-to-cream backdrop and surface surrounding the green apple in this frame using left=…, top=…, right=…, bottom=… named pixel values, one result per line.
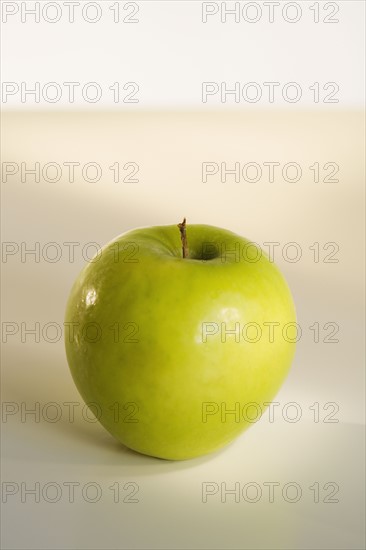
left=1, top=1, right=365, bottom=550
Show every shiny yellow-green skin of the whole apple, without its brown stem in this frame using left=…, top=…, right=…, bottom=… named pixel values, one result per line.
left=65, top=225, right=296, bottom=460
